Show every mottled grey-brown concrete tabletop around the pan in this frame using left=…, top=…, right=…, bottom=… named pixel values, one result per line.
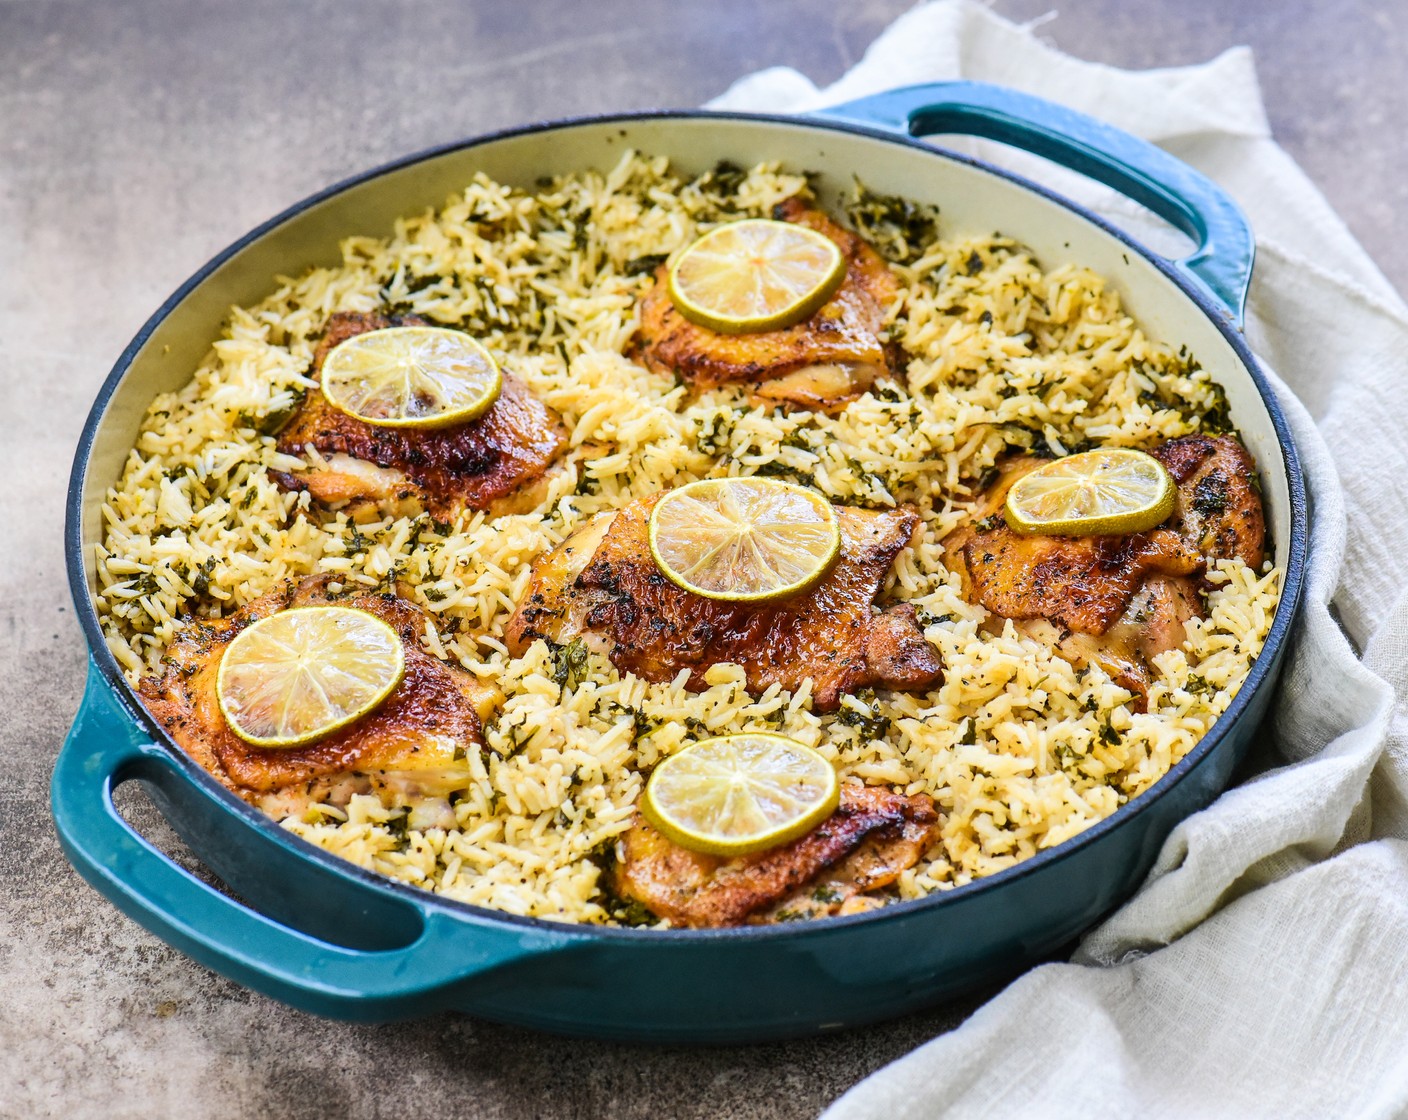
left=0, top=0, right=1408, bottom=1120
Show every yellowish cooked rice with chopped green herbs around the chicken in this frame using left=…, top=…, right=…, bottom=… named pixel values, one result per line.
left=97, top=155, right=1280, bottom=921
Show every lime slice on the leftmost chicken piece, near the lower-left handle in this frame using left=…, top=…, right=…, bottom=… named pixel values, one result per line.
left=215, top=607, right=406, bottom=747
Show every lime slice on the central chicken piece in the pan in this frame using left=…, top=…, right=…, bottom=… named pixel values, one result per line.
left=650, top=478, right=841, bottom=603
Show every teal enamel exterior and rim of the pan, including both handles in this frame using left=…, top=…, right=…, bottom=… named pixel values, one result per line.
left=51, top=85, right=1307, bottom=1043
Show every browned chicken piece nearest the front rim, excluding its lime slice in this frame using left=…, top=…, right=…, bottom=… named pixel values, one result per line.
left=611, top=785, right=939, bottom=928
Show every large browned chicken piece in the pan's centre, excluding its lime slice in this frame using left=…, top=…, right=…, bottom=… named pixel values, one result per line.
left=505, top=494, right=942, bottom=711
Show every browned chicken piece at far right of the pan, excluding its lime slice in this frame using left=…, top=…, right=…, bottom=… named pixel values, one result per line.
left=943, top=435, right=1266, bottom=710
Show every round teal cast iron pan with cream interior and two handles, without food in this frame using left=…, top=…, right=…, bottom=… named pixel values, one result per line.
left=52, top=83, right=1307, bottom=1043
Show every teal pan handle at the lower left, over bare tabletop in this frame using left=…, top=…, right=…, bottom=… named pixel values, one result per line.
left=51, top=661, right=572, bottom=1020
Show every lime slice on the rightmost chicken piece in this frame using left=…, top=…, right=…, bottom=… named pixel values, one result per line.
left=1004, top=448, right=1177, bottom=537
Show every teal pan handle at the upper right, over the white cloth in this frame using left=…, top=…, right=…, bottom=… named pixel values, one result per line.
left=811, top=82, right=1256, bottom=327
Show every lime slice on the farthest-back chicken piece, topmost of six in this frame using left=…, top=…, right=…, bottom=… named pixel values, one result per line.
left=670, top=218, right=846, bottom=334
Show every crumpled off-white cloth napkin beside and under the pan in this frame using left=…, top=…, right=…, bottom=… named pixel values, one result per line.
left=714, top=0, right=1408, bottom=1120
